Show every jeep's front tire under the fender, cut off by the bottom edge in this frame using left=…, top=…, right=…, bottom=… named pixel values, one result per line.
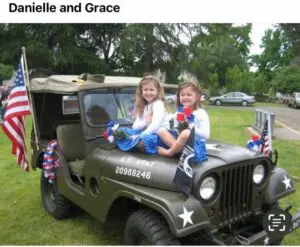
left=124, top=209, right=180, bottom=245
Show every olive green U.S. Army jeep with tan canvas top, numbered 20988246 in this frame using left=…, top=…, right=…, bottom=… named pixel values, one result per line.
left=30, top=75, right=300, bottom=245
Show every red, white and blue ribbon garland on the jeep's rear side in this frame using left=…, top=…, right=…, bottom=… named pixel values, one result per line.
left=43, top=140, right=60, bottom=183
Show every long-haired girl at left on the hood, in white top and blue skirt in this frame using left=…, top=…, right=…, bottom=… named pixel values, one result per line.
left=112, top=75, right=169, bottom=154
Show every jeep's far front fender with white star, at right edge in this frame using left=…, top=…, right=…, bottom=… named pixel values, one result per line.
left=263, top=168, right=295, bottom=204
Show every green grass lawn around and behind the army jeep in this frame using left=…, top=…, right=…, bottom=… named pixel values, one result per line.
left=0, top=110, right=300, bottom=245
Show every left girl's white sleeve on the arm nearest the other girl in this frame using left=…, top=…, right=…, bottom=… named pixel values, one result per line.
left=143, top=100, right=165, bottom=134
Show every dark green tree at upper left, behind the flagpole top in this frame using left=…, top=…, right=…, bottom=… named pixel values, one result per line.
left=0, top=24, right=105, bottom=74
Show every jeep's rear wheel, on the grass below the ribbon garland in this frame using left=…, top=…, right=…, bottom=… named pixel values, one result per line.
left=41, top=170, right=72, bottom=220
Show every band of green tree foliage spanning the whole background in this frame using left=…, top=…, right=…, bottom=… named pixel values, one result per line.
left=0, top=23, right=300, bottom=94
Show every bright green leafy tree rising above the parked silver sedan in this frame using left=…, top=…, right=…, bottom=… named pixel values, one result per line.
left=187, top=24, right=251, bottom=87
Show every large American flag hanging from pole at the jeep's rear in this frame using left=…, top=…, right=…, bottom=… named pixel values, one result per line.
left=2, top=56, right=31, bottom=171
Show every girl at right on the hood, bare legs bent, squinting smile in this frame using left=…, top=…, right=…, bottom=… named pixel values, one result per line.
left=157, top=81, right=210, bottom=156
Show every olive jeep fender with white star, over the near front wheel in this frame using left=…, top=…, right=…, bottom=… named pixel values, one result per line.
left=106, top=180, right=212, bottom=237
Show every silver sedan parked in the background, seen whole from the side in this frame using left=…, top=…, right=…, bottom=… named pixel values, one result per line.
left=209, top=92, right=255, bottom=106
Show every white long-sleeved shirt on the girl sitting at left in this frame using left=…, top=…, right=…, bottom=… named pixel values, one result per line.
left=132, top=100, right=169, bottom=134
